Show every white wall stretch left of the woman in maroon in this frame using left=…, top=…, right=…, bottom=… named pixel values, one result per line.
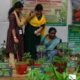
left=0, top=0, right=11, bottom=44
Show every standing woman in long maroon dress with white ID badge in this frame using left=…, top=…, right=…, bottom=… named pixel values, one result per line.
left=6, top=1, right=24, bottom=66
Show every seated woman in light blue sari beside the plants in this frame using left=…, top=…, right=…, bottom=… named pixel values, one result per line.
left=41, top=27, right=62, bottom=60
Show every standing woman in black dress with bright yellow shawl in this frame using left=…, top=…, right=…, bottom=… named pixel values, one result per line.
left=24, top=4, right=46, bottom=60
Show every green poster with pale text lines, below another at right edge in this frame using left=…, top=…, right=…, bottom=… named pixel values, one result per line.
left=68, top=25, right=80, bottom=54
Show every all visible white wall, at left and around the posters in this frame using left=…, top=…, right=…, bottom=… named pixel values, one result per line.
left=0, top=0, right=72, bottom=44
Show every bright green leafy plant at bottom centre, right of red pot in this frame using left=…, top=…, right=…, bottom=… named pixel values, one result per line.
left=25, top=68, right=53, bottom=80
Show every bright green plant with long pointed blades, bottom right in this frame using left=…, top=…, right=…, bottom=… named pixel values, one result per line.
left=51, top=62, right=80, bottom=80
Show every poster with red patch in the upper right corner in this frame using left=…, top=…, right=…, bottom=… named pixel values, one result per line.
left=71, top=0, right=80, bottom=24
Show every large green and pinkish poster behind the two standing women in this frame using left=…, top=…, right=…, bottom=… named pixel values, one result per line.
left=13, top=0, right=67, bottom=26
